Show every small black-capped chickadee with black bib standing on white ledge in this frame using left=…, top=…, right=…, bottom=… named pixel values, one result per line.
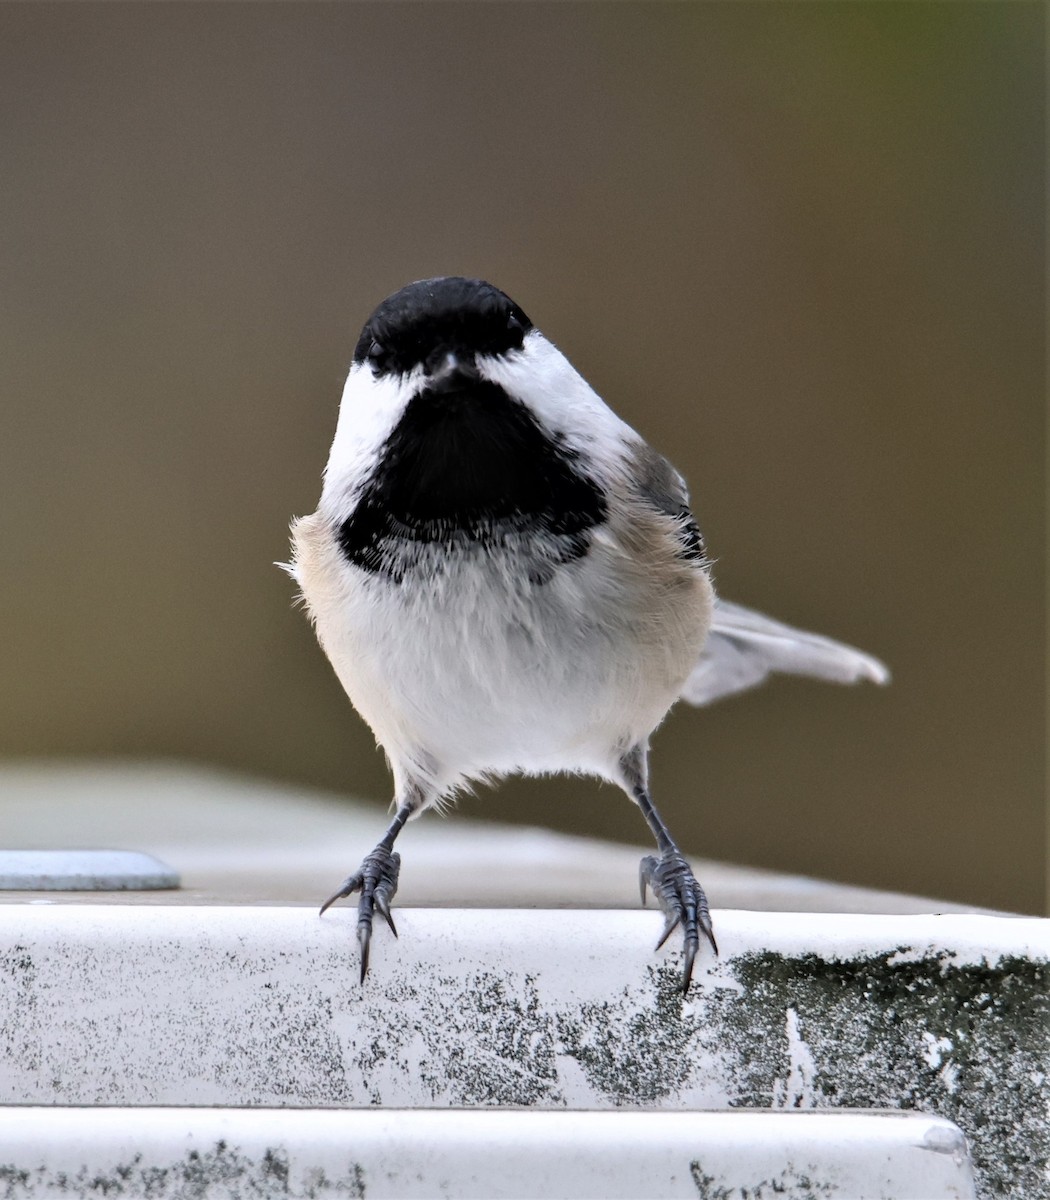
left=283, top=276, right=889, bottom=994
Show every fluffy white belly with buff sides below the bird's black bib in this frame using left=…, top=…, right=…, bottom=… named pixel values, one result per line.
left=296, top=518, right=709, bottom=788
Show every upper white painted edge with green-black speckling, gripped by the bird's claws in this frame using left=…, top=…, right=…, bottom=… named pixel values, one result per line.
left=0, top=905, right=1050, bottom=1200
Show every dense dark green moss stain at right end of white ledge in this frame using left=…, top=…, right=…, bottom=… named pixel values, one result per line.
left=733, top=949, right=1050, bottom=1200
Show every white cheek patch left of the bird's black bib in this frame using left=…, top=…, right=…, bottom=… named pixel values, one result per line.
left=320, top=362, right=422, bottom=516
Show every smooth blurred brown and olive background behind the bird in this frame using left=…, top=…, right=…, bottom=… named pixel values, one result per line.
left=0, top=2, right=1046, bottom=912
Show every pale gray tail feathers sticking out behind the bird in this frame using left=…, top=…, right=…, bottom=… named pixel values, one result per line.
left=682, top=599, right=889, bottom=704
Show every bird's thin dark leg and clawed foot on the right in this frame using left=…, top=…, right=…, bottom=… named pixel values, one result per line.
left=619, top=745, right=719, bottom=995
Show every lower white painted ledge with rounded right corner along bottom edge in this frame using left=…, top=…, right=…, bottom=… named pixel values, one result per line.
left=0, top=1109, right=974, bottom=1200
